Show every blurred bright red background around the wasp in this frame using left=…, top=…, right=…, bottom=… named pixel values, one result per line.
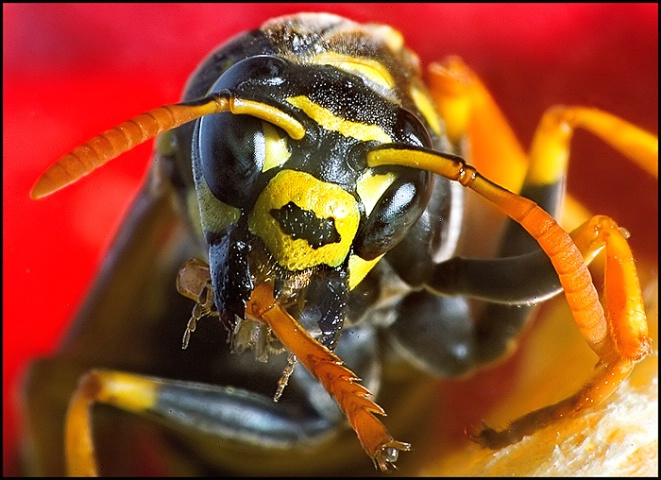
left=3, top=3, right=658, bottom=474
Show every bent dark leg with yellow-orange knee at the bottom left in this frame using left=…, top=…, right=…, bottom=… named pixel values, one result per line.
left=60, top=327, right=378, bottom=476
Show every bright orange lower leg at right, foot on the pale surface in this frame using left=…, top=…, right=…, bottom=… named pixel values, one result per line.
left=469, top=216, right=651, bottom=448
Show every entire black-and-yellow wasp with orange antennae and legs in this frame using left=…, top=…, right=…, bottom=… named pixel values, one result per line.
left=19, top=14, right=658, bottom=475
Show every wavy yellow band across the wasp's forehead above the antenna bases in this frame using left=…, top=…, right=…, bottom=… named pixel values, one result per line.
left=287, top=95, right=393, bottom=143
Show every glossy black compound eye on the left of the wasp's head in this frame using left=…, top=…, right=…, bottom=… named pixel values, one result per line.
left=197, top=113, right=264, bottom=208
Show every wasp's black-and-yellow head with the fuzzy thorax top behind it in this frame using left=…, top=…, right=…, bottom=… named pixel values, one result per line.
left=183, top=16, right=440, bottom=346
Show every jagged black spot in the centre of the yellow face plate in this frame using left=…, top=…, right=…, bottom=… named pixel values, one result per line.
left=271, top=202, right=340, bottom=249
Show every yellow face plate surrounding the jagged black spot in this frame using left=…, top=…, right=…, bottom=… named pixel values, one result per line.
left=248, top=170, right=360, bottom=271
